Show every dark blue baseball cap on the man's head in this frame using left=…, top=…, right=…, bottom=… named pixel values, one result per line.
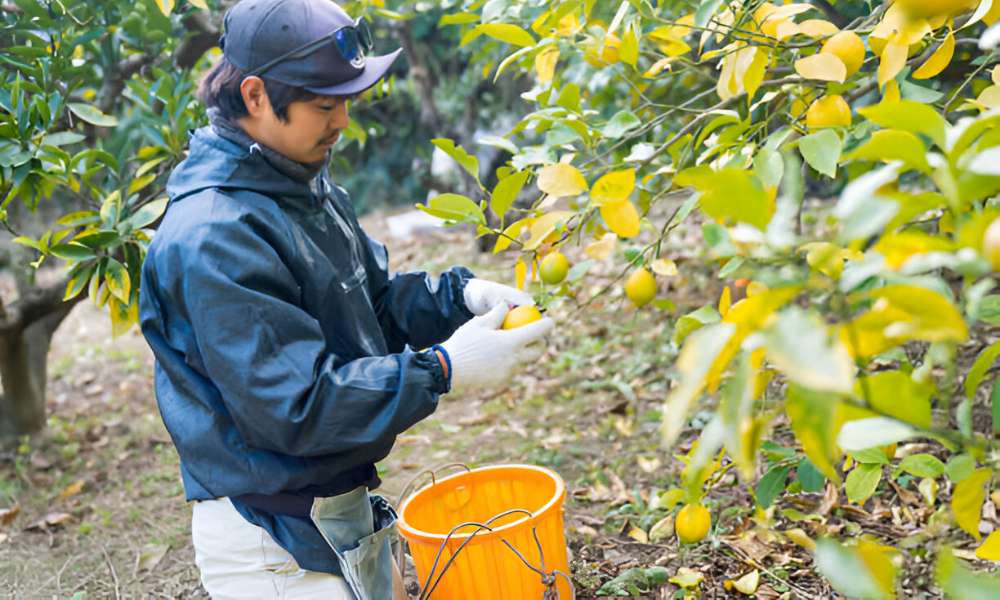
left=221, top=0, right=402, bottom=96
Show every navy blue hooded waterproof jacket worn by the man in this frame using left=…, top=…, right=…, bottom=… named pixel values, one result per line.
left=140, top=120, right=472, bottom=573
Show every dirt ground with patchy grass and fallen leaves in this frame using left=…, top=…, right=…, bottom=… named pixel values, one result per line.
left=0, top=203, right=996, bottom=600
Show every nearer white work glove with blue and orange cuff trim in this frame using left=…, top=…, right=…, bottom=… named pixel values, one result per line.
left=441, top=303, right=555, bottom=389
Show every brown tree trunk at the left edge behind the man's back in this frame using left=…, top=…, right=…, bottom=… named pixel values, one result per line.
left=0, top=282, right=85, bottom=440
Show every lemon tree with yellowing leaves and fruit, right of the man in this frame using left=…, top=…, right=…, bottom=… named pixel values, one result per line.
left=426, top=0, right=1000, bottom=597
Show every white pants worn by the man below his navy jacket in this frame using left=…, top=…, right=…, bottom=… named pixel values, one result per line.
left=191, top=498, right=354, bottom=600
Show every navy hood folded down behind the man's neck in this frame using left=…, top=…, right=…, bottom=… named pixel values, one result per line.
left=167, top=126, right=313, bottom=203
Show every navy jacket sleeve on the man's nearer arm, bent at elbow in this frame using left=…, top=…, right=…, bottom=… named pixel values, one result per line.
left=178, top=222, right=448, bottom=456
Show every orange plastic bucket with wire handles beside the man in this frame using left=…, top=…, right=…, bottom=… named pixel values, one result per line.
left=399, top=465, right=573, bottom=600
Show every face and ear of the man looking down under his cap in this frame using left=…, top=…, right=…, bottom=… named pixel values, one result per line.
left=244, top=89, right=349, bottom=163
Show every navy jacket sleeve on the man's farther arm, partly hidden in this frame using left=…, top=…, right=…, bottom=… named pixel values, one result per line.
left=365, top=235, right=474, bottom=351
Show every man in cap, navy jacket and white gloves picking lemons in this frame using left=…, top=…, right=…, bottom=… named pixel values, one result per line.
left=140, top=0, right=552, bottom=600
